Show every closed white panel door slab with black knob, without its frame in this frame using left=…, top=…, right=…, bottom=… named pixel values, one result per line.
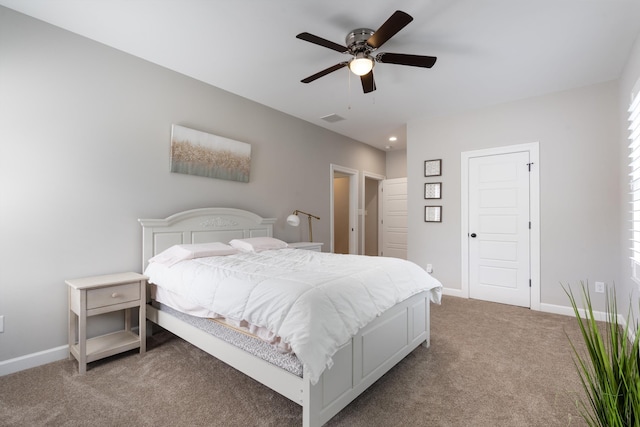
left=468, top=152, right=531, bottom=307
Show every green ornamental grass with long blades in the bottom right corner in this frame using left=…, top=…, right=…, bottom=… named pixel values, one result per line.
left=563, top=283, right=640, bottom=427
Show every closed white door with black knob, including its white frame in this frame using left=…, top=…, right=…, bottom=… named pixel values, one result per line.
left=461, top=143, right=540, bottom=310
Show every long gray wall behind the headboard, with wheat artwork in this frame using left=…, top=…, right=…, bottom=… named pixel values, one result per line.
left=0, top=7, right=385, bottom=361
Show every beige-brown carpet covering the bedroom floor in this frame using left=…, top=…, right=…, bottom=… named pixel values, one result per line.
left=0, top=297, right=585, bottom=427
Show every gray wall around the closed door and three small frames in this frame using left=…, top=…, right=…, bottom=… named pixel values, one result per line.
left=407, top=82, right=626, bottom=306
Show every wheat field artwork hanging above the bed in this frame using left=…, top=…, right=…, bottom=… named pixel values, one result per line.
left=171, top=125, right=251, bottom=182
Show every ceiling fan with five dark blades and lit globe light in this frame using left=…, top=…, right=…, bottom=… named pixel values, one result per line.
left=296, top=10, right=437, bottom=93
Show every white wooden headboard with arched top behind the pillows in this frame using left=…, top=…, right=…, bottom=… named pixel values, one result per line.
left=138, top=208, right=276, bottom=271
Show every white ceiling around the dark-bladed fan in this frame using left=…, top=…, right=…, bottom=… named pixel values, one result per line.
left=0, top=0, right=640, bottom=149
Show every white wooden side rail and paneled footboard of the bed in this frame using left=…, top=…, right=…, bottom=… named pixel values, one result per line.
left=147, top=292, right=430, bottom=427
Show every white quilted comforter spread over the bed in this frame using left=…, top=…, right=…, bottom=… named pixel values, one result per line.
left=145, top=249, right=442, bottom=384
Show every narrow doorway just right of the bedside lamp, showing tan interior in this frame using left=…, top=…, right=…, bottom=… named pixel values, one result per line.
left=330, top=164, right=358, bottom=254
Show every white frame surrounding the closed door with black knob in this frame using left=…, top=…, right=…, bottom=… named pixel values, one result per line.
left=460, top=142, right=540, bottom=311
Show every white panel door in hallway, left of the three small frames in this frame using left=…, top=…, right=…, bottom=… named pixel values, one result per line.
left=380, top=178, right=408, bottom=259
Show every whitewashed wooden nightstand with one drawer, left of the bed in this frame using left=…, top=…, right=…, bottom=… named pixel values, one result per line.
left=65, top=273, right=147, bottom=374
